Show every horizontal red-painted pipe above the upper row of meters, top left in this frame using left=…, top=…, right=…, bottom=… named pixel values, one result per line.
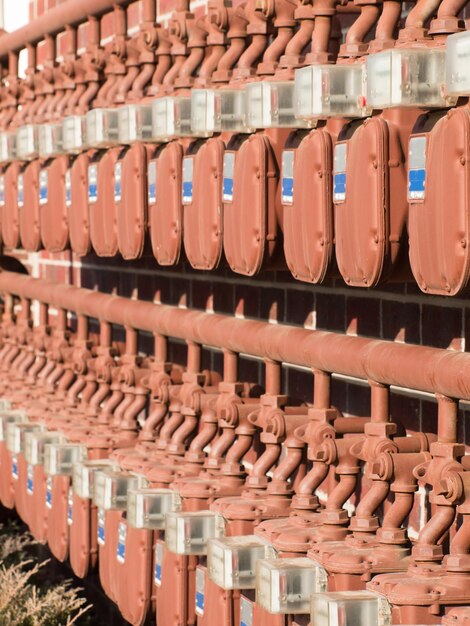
left=0, top=0, right=135, bottom=58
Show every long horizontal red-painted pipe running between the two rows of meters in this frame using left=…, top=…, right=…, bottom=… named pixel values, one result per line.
left=0, top=272, right=470, bottom=400
